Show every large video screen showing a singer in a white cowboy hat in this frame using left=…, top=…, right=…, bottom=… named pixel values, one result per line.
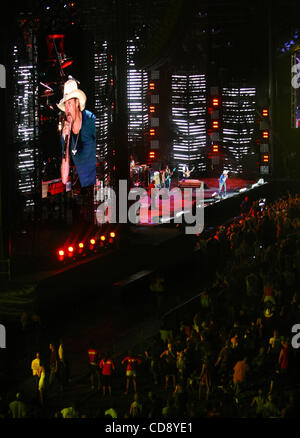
left=39, top=34, right=96, bottom=197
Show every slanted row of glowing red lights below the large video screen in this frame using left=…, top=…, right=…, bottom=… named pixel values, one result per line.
left=57, top=231, right=117, bottom=262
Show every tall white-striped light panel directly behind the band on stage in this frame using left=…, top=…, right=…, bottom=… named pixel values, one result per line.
left=172, top=73, right=206, bottom=171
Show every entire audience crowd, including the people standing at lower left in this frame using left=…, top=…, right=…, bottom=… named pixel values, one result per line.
left=1, top=194, right=300, bottom=418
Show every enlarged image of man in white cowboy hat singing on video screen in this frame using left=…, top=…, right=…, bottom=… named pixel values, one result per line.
left=57, top=79, right=96, bottom=223
